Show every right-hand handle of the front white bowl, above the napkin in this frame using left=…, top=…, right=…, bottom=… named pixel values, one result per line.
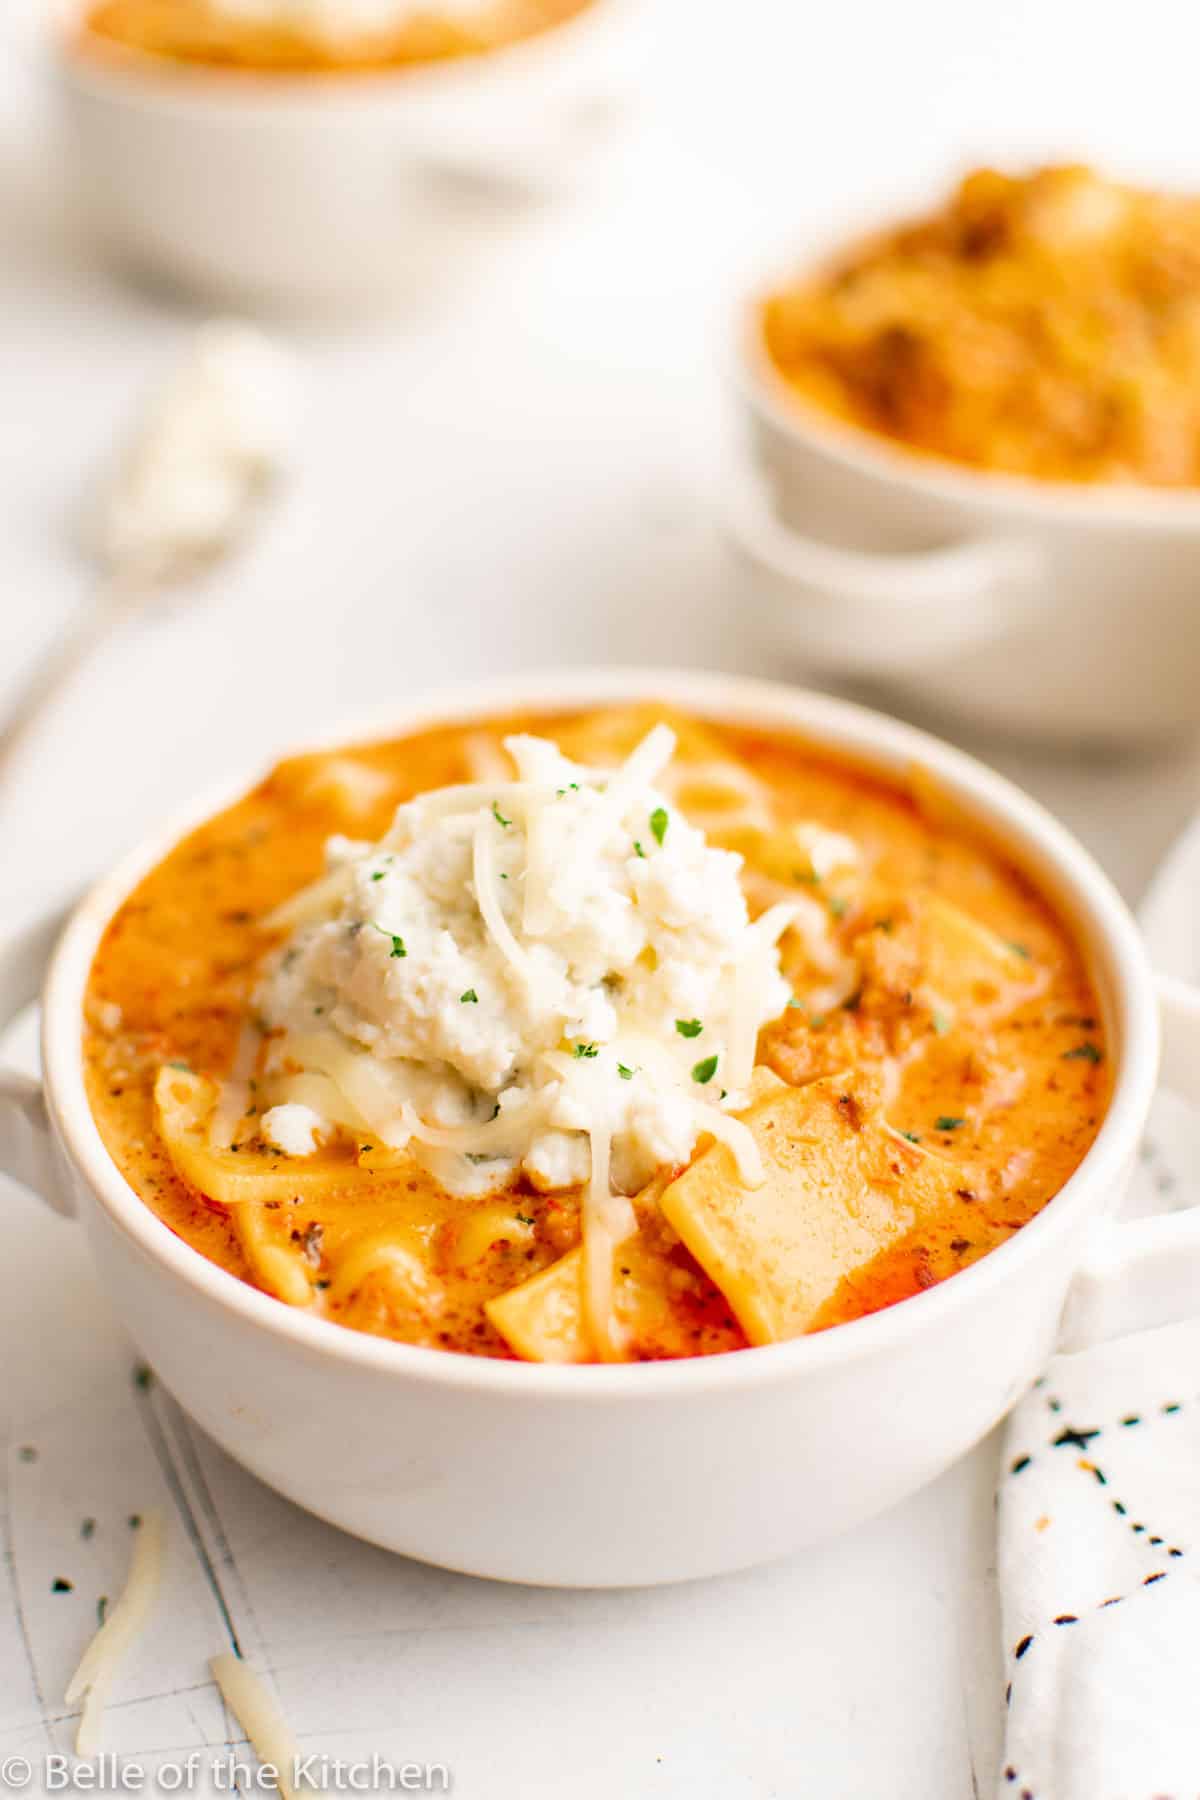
left=1058, top=976, right=1200, bottom=1352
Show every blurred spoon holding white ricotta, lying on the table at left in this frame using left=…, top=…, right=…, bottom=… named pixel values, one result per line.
left=0, top=320, right=297, bottom=778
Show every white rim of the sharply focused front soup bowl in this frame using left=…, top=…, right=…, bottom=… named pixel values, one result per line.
left=41, top=668, right=1159, bottom=1402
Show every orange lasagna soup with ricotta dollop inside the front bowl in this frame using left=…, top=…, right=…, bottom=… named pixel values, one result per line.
left=85, top=707, right=1108, bottom=1363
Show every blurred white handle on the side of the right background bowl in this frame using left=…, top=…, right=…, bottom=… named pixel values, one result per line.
left=723, top=468, right=1045, bottom=675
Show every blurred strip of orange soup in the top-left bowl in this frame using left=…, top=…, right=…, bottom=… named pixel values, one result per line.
left=83, top=0, right=590, bottom=74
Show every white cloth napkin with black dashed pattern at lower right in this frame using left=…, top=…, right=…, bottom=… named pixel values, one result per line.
left=999, top=1321, right=1200, bottom=1800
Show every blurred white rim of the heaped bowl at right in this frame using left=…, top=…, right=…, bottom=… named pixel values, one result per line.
left=730, top=248, right=1200, bottom=531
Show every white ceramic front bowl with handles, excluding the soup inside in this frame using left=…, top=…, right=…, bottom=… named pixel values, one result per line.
left=0, top=671, right=1200, bottom=1586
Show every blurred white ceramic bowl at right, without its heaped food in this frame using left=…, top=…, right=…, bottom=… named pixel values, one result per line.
left=725, top=261, right=1200, bottom=745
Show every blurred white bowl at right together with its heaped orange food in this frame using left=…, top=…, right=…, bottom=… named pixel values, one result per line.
left=725, top=169, right=1200, bottom=745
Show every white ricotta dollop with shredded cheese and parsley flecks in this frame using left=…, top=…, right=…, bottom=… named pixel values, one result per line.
left=257, top=725, right=802, bottom=1353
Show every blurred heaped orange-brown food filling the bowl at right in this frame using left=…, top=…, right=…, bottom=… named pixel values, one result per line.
left=763, top=167, right=1200, bottom=488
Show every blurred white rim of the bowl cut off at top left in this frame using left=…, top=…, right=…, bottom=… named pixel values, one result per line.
left=45, top=0, right=633, bottom=113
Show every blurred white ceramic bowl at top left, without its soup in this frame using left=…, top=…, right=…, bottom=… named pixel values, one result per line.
left=49, top=0, right=640, bottom=310
